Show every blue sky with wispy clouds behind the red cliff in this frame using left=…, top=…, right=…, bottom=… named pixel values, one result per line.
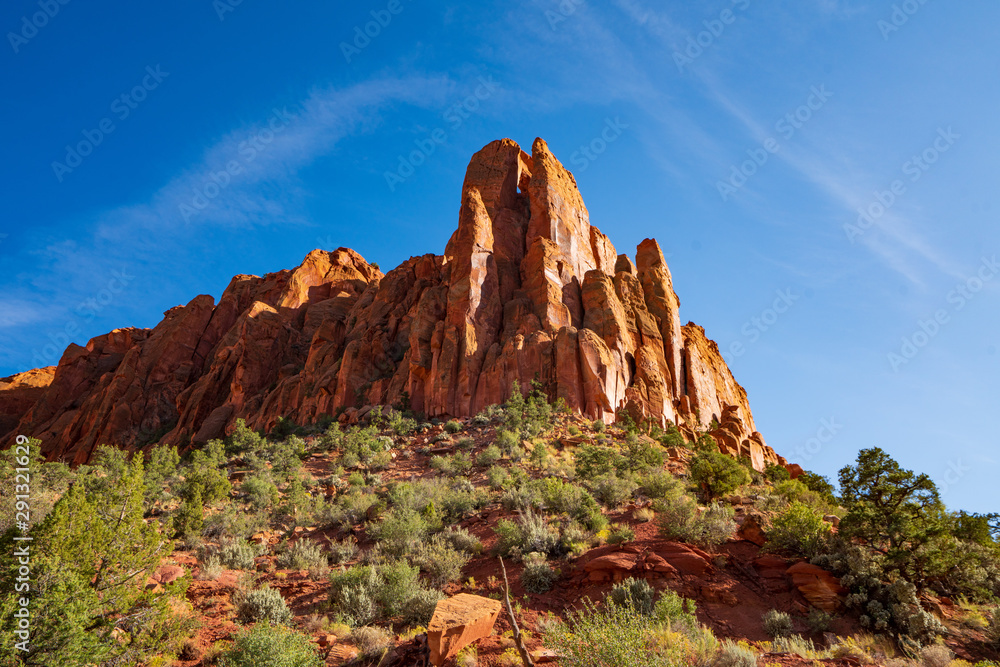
left=0, top=0, right=1000, bottom=512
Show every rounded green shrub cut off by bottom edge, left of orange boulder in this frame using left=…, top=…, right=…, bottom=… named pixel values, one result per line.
left=218, top=623, right=325, bottom=667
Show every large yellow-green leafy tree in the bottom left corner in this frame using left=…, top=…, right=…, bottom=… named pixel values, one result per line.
left=0, top=456, right=184, bottom=667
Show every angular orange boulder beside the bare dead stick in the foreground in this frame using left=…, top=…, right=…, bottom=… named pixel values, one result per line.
left=427, top=593, right=501, bottom=667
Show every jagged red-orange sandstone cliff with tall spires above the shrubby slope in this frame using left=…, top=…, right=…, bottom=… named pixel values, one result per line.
left=0, top=139, right=784, bottom=468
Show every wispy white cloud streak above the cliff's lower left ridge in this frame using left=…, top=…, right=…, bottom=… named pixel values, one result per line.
left=0, top=76, right=457, bottom=370
